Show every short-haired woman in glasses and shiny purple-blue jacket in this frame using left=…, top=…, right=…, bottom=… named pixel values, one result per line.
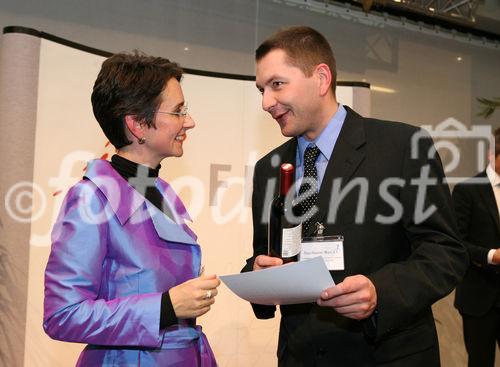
left=43, top=54, right=220, bottom=367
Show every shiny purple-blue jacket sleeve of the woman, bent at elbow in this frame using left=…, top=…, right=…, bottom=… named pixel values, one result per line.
left=43, top=181, right=161, bottom=347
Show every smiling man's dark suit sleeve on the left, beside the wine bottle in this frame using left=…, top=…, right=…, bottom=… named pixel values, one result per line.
left=241, top=162, right=276, bottom=319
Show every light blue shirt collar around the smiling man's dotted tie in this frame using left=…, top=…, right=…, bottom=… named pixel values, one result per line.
left=298, top=103, right=347, bottom=165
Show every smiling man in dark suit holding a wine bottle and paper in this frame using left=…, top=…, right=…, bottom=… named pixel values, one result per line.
left=243, top=27, right=467, bottom=367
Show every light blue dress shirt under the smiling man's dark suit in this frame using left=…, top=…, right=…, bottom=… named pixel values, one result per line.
left=295, top=104, right=347, bottom=192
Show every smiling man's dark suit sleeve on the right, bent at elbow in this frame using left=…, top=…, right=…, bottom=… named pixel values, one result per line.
left=369, top=129, right=468, bottom=338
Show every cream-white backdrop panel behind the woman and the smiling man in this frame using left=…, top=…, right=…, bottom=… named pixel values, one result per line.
left=25, top=36, right=369, bottom=367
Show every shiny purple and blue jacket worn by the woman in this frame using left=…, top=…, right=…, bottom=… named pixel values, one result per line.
left=43, top=160, right=217, bottom=367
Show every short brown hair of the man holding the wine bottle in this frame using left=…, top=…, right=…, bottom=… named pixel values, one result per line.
left=255, top=26, right=337, bottom=94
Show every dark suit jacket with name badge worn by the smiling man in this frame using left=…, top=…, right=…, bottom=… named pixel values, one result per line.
left=243, top=109, right=468, bottom=367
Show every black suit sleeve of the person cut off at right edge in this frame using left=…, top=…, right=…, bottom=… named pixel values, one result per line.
left=452, top=184, right=489, bottom=267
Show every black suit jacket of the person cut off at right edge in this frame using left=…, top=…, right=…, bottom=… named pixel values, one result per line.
left=453, top=171, right=500, bottom=316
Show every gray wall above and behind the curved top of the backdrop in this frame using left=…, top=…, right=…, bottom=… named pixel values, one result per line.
left=0, top=0, right=500, bottom=135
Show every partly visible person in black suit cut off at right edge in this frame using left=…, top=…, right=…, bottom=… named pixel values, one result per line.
left=453, top=128, right=500, bottom=367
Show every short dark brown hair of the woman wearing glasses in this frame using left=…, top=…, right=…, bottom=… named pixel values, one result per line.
left=91, top=51, right=182, bottom=149
